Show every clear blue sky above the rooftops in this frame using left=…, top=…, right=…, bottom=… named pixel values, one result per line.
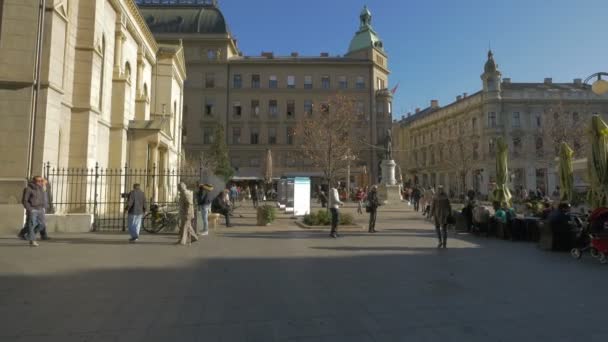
left=219, top=0, right=608, bottom=118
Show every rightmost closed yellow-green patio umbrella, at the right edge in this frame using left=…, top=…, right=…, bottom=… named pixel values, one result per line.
left=587, top=115, right=608, bottom=209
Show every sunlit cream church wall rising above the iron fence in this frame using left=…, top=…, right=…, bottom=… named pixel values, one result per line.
left=0, top=0, right=186, bottom=229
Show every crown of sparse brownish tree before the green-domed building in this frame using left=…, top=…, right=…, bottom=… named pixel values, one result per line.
left=296, top=94, right=363, bottom=184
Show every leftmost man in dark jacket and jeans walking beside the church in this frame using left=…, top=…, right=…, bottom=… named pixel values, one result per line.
left=21, top=176, right=48, bottom=247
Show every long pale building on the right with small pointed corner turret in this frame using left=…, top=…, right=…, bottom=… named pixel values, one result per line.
left=393, top=51, right=608, bottom=194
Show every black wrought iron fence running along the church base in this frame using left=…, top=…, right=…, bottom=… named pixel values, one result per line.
left=44, top=163, right=203, bottom=231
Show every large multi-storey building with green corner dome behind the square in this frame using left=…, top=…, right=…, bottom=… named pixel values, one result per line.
left=138, top=0, right=392, bottom=184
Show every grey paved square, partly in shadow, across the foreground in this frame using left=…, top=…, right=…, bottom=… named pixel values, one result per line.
left=0, top=202, right=608, bottom=342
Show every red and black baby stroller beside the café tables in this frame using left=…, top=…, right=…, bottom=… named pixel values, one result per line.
left=570, top=208, right=608, bottom=264
